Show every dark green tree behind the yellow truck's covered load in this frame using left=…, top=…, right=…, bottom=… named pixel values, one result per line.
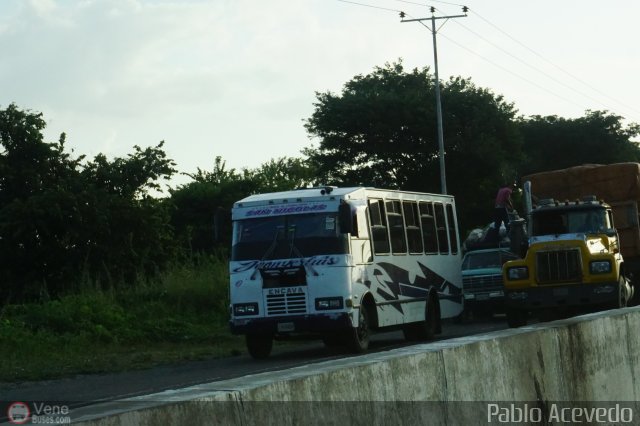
left=518, top=111, right=640, bottom=175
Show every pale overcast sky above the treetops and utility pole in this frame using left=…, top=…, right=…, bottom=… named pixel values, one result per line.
left=0, top=0, right=640, bottom=188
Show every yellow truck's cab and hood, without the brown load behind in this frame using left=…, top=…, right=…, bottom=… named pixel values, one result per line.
left=502, top=197, right=633, bottom=327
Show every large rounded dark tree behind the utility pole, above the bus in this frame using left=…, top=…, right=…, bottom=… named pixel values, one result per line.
left=304, top=61, right=522, bottom=230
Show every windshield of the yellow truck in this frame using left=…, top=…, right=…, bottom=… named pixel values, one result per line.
left=532, top=208, right=611, bottom=236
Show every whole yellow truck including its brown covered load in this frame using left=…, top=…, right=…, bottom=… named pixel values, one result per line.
left=502, top=163, right=640, bottom=327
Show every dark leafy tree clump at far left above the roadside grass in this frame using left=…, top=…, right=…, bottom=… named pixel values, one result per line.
left=0, top=104, right=179, bottom=300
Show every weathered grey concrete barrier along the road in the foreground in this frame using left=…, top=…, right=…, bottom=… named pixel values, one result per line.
left=66, top=308, right=640, bottom=426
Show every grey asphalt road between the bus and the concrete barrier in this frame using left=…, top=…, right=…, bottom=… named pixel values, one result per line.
left=0, top=316, right=507, bottom=406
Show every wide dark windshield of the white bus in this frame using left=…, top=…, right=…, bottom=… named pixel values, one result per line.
left=231, top=213, right=348, bottom=260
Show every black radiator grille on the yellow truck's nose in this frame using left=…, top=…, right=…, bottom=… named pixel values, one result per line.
left=536, top=248, right=582, bottom=284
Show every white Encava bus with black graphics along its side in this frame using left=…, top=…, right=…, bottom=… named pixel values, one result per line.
left=230, top=187, right=462, bottom=358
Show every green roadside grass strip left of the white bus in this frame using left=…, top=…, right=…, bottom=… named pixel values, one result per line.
left=0, top=255, right=245, bottom=382
